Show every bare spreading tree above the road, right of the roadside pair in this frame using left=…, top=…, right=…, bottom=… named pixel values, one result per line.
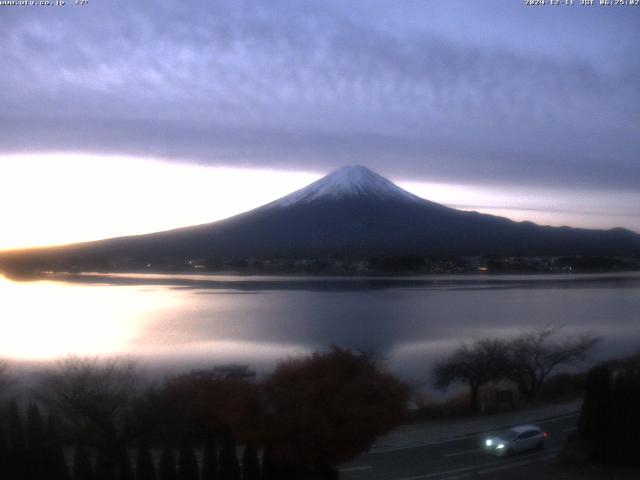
left=506, top=327, right=600, bottom=401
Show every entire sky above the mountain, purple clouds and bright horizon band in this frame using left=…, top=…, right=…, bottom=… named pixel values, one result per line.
left=0, top=0, right=640, bottom=249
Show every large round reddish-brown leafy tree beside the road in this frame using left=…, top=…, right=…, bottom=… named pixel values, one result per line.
left=263, top=347, right=409, bottom=471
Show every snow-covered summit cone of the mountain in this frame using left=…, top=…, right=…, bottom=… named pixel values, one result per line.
left=270, top=165, right=423, bottom=207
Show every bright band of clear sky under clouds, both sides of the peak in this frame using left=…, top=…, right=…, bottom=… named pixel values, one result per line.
left=0, top=154, right=640, bottom=250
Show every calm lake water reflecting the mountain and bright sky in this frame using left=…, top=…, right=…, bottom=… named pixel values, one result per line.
left=0, top=273, right=640, bottom=380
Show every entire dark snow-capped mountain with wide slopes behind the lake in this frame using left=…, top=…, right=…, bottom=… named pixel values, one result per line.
left=0, top=166, right=640, bottom=271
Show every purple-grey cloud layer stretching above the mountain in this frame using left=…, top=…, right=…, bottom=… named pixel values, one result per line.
left=0, top=1, right=640, bottom=191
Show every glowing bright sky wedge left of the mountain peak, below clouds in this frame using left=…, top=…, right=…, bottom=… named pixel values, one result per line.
left=0, top=154, right=320, bottom=250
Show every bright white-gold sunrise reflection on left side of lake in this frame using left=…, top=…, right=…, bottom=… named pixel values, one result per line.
left=0, top=276, right=176, bottom=360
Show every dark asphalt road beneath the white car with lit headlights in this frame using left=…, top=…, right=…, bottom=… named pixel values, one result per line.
left=340, top=414, right=578, bottom=480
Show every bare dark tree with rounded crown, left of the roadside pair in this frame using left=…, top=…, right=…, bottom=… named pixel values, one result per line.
left=433, top=338, right=508, bottom=412
